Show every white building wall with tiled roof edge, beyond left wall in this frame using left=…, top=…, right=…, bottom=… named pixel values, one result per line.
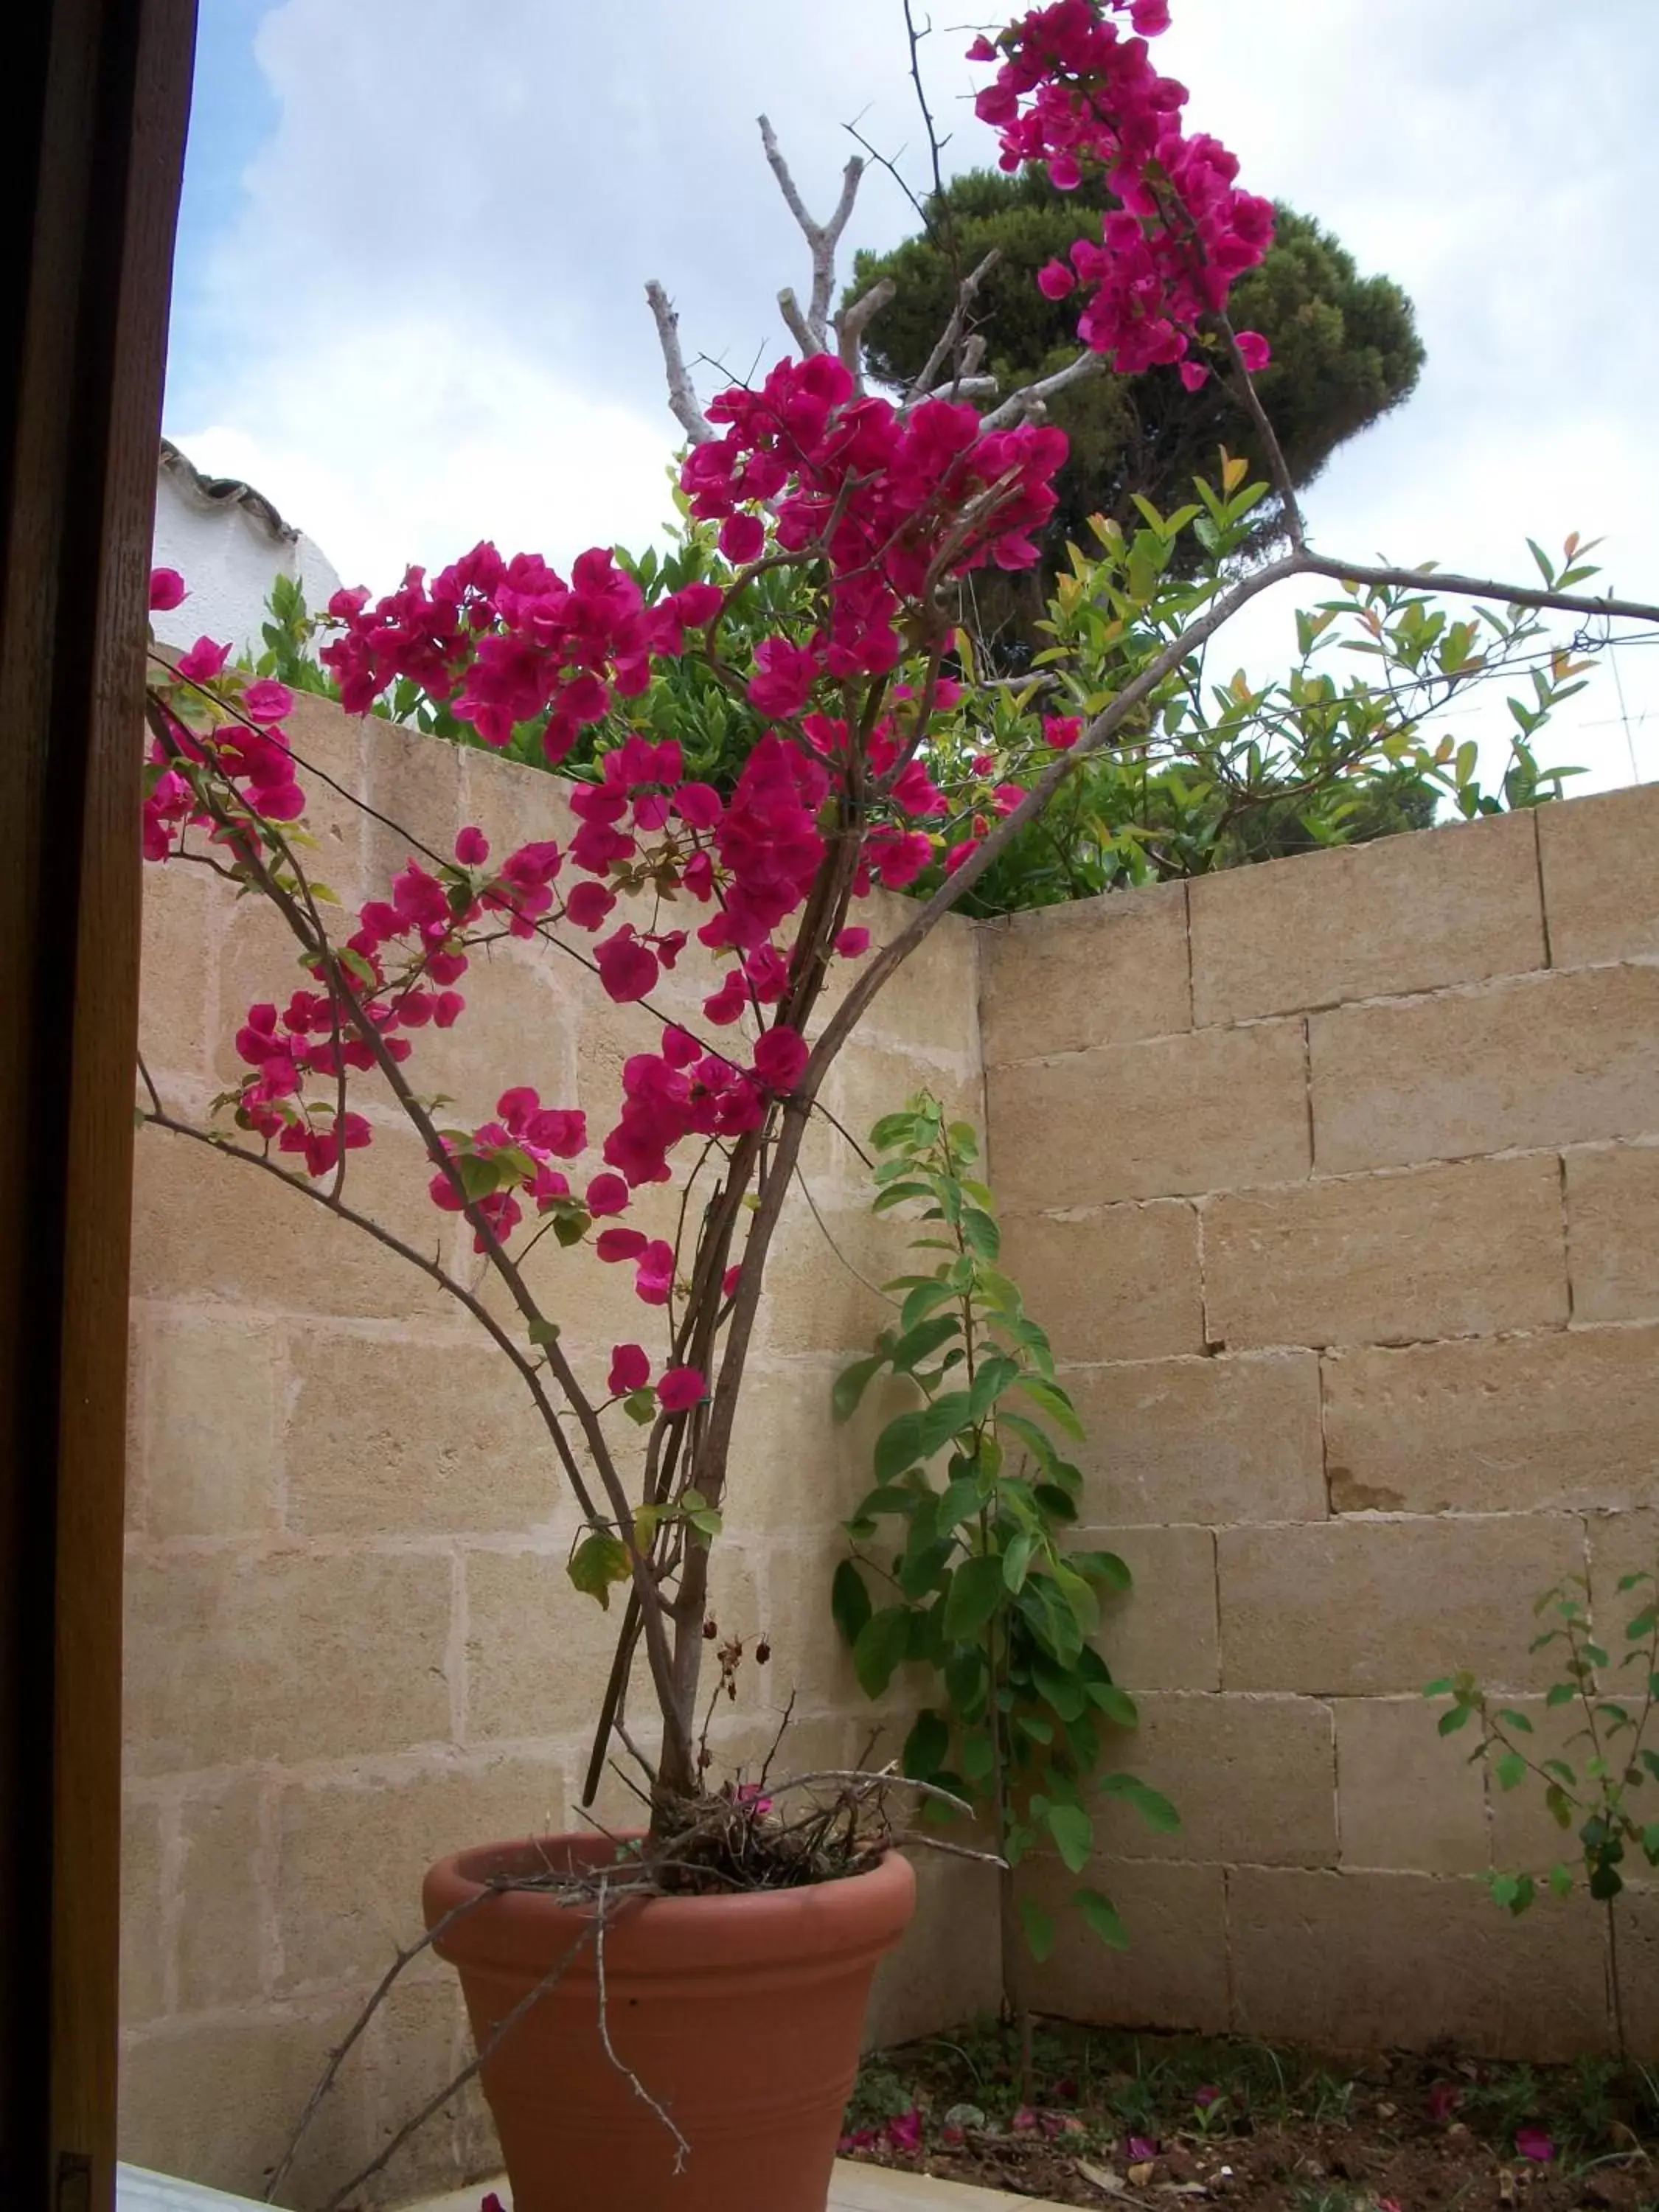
left=150, top=453, right=341, bottom=653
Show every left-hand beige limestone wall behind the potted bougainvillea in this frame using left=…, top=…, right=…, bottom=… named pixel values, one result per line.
left=122, top=703, right=995, bottom=2203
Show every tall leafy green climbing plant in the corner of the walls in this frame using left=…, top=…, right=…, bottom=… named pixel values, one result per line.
left=832, top=1093, right=1179, bottom=2017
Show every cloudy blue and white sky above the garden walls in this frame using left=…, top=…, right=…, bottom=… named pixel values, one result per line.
left=166, top=0, right=1659, bottom=783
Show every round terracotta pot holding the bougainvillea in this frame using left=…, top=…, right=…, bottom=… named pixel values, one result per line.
left=422, top=1836, right=916, bottom=2212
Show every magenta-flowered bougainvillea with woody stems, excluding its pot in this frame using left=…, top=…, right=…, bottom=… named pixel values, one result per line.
left=142, top=0, right=1659, bottom=1834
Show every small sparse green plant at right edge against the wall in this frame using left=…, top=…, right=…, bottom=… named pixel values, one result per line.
left=1422, top=1568, right=1659, bottom=2064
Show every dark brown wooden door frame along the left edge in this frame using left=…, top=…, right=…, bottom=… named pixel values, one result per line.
left=0, top=0, right=195, bottom=2212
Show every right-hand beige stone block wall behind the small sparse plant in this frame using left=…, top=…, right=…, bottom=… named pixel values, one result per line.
left=982, top=787, right=1659, bottom=2057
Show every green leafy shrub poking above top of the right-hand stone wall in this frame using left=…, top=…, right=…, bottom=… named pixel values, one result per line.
left=918, top=489, right=1597, bottom=916
